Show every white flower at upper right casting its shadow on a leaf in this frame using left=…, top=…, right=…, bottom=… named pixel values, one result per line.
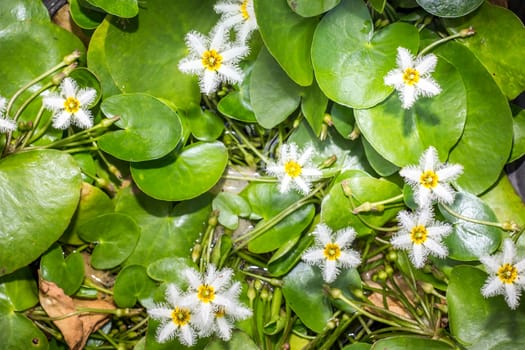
left=384, top=47, right=441, bottom=109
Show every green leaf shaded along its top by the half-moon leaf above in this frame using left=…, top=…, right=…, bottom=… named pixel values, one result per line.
left=115, top=188, right=211, bottom=267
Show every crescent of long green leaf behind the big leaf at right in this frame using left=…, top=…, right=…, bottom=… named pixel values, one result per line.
left=437, top=43, right=512, bottom=194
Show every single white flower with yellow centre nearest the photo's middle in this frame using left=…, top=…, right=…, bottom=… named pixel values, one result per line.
left=266, top=143, right=322, bottom=194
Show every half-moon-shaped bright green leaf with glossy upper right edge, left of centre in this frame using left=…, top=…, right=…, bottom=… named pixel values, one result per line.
left=131, top=142, right=228, bottom=201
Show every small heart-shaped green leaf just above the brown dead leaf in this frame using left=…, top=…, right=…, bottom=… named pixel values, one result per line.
left=40, top=244, right=84, bottom=295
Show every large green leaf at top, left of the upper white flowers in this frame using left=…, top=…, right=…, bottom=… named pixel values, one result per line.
left=104, top=0, right=218, bottom=109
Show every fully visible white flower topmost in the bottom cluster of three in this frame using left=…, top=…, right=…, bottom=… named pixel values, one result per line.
left=182, top=265, right=239, bottom=329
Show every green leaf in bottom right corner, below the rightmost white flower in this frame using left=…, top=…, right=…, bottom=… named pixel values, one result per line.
left=447, top=266, right=525, bottom=350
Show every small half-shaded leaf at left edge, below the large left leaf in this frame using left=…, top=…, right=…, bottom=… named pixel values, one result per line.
left=0, top=266, right=38, bottom=311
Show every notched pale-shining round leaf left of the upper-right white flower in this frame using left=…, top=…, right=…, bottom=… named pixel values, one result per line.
left=312, top=0, right=419, bottom=108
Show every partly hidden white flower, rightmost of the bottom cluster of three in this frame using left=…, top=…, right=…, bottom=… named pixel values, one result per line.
left=200, top=282, right=252, bottom=341
